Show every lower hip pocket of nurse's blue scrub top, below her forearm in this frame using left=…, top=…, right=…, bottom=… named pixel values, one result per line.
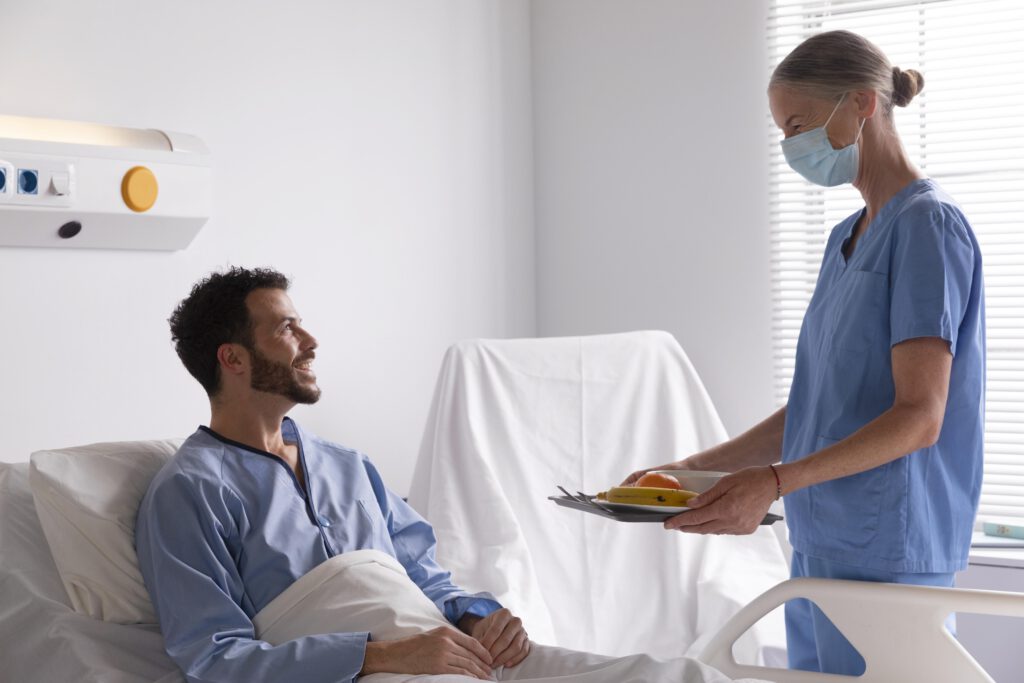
left=809, top=436, right=892, bottom=550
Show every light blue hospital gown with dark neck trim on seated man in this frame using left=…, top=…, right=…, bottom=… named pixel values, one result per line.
left=136, top=418, right=500, bottom=683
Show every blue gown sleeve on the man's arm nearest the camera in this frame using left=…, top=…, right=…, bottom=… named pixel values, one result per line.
left=136, top=475, right=369, bottom=683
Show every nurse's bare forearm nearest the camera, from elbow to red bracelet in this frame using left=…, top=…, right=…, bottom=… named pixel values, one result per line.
left=775, top=404, right=941, bottom=496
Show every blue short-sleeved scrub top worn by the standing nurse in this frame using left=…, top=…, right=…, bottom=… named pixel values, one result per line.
left=782, top=179, right=985, bottom=572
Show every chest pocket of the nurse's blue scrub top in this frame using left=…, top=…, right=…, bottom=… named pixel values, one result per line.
left=831, top=270, right=889, bottom=351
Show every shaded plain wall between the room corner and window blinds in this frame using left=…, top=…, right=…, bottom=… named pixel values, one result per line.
left=531, top=0, right=773, bottom=436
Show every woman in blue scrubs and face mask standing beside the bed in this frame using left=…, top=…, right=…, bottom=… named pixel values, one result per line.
left=627, top=31, right=985, bottom=675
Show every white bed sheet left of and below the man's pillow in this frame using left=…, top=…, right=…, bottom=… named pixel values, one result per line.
left=0, top=463, right=184, bottom=683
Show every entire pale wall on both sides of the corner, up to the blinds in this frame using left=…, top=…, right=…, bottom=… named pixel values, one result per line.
left=0, top=0, right=771, bottom=492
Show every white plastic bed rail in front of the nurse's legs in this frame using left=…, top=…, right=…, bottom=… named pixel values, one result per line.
left=698, top=579, right=1024, bottom=683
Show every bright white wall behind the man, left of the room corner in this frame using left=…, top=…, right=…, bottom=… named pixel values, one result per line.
left=0, top=0, right=536, bottom=492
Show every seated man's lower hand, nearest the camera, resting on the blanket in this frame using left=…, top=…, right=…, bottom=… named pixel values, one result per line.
left=359, top=626, right=493, bottom=681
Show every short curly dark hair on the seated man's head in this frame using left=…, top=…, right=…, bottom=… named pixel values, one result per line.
left=167, top=267, right=291, bottom=397
